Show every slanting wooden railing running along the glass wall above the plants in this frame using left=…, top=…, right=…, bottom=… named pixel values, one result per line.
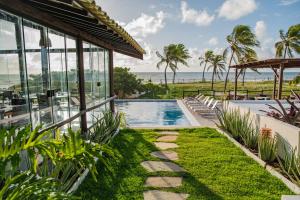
left=39, top=95, right=117, bottom=133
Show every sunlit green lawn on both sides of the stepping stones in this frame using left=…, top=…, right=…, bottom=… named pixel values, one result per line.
left=77, top=128, right=291, bottom=200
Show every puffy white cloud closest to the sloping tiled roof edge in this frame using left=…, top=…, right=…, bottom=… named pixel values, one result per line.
left=121, top=11, right=166, bottom=37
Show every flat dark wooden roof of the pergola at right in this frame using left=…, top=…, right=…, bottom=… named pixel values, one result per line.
left=230, top=58, right=300, bottom=69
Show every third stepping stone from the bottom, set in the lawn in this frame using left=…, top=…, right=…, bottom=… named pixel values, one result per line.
left=141, top=161, right=185, bottom=172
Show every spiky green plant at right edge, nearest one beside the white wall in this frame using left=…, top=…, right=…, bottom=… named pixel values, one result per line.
left=277, top=148, right=300, bottom=186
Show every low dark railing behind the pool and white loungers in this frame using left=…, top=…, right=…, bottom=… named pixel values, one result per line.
left=182, top=89, right=300, bottom=99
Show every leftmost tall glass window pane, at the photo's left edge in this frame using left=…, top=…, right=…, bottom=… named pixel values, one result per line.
left=0, top=10, right=30, bottom=127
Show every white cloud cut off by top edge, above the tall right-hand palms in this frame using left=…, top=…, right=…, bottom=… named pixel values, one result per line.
left=219, top=0, right=257, bottom=20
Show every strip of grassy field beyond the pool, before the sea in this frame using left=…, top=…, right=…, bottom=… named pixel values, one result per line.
left=139, top=81, right=299, bottom=99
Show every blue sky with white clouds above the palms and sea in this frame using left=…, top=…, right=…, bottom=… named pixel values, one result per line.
left=96, top=0, right=300, bottom=72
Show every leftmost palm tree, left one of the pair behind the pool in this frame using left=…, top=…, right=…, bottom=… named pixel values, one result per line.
left=156, top=44, right=176, bottom=89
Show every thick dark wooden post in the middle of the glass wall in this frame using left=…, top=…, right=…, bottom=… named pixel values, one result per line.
left=76, top=38, right=87, bottom=135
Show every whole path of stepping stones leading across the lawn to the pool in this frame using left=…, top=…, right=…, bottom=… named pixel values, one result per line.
left=141, top=131, right=189, bottom=200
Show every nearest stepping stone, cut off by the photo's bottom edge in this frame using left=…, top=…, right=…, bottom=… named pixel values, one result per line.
left=144, top=190, right=189, bottom=200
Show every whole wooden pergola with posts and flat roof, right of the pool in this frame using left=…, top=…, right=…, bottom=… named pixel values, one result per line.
left=230, top=58, right=300, bottom=100
